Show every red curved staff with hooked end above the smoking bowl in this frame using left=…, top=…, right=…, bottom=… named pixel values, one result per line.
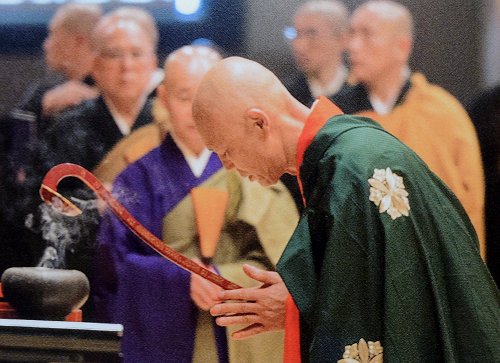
left=40, top=163, right=240, bottom=290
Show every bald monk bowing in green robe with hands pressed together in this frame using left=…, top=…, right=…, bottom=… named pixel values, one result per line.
left=193, top=57, right=500, bottom=363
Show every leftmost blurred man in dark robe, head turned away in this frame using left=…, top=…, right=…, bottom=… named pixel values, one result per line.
left=8, top=3, right=102, bottom=183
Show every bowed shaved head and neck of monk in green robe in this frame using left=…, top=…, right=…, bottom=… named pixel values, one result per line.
left=193, top=57, right=308, bottom=185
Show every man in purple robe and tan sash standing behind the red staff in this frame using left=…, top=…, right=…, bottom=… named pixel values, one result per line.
left=92, top=46, right=297, bottom=363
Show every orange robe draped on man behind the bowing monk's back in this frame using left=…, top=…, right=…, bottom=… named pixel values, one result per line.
left=358, top=73, right=486, bottom=259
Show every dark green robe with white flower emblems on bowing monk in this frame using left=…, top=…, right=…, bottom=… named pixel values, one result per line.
left=278, top=100, right=500, bottom=363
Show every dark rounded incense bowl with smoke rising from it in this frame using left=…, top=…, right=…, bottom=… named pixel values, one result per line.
left=2, top=267, right=89, bottom=320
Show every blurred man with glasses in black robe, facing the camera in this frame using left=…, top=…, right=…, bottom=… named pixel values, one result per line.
left=32, top=7, right=158, bottom=189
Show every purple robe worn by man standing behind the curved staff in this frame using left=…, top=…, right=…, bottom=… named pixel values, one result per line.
left=92, top=136, right=227, bottom=363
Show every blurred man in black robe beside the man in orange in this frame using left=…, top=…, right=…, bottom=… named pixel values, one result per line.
left=282, top=0, right=349, bottom=212
